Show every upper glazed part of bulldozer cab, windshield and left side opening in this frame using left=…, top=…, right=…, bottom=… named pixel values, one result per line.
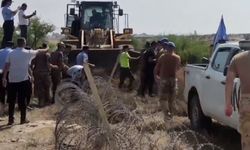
left=66, top=1, right=113, bottom=30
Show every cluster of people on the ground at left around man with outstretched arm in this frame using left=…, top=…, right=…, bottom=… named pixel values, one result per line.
left=0, top=37, right=72, bottom=125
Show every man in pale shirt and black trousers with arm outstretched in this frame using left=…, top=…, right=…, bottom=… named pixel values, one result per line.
left=3, top=38, right=48, bottom=125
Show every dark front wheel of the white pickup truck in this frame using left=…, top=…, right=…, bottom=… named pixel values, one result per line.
left=189, top=95, right=212, bottom=130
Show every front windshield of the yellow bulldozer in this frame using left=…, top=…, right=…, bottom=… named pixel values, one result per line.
left=82, top=6, right=113, bottom=30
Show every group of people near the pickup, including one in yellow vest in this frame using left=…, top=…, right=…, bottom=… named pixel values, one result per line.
left=119, top=38, right=181, bottom=118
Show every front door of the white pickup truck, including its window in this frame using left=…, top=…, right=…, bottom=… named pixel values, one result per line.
left=202, top=47, right=236, bottom=124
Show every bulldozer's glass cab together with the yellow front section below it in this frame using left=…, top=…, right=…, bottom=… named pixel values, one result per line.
left=62, top=1, right=114, bottom=48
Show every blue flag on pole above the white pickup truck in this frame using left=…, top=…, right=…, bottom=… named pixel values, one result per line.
left=213, top=16, right=228, bottom=48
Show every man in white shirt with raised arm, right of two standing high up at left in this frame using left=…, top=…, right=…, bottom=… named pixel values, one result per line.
left=18, top=3, right=36, bottom=40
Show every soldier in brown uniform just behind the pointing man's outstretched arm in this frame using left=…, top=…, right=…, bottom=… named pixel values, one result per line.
left=31, top=44, right=57, bottom=107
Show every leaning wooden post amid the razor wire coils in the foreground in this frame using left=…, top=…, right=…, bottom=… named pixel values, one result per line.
left=83, top=63, right=118, bottom=150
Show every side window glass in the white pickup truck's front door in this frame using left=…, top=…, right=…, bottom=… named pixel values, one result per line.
left=212, top=48, right=231, bottom=72
